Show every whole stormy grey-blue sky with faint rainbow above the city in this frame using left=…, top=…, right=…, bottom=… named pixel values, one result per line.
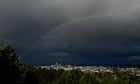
left=0, top=0, right=140, bottom=65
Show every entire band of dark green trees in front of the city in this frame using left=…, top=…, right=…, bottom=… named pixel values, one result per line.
left=0, top=45, right=140, bottom=84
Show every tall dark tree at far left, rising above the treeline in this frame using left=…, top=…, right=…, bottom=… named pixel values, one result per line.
left=0, top=45, right=20, bottom=84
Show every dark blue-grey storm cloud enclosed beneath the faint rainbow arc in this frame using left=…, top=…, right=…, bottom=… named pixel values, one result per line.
left=26, top=16, right=140, bottom=63
